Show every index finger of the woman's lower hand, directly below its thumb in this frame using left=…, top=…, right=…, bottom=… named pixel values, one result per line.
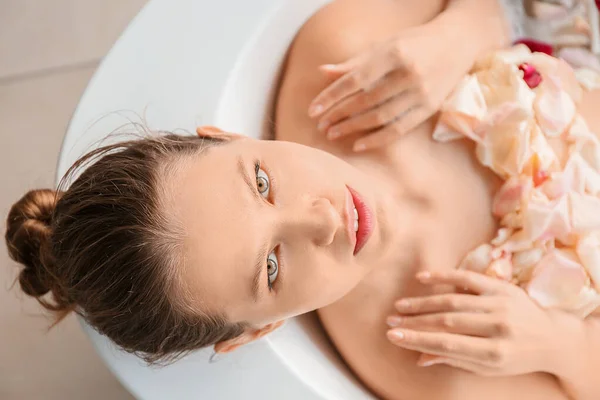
left=394, top=293, right=496, bottom=315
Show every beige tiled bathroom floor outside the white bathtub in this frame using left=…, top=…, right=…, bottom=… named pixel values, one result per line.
left=0, top=0, right=146, bottom=400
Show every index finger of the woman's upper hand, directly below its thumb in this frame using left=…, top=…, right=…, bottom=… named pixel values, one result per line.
left=308, top=57, right=393, bottom=118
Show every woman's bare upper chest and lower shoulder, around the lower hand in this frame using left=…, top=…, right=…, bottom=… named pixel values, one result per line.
left=319, top=132, right=564, bottom=400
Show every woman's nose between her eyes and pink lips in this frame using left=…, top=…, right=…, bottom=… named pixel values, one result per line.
left=283, top=197, right=341, bottom=246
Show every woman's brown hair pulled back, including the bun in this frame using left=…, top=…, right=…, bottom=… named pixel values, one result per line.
left=6, top=134, right=245, bottom=363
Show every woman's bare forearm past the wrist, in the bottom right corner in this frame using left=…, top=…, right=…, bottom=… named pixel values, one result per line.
left=548, top=314, right=600, bottom=400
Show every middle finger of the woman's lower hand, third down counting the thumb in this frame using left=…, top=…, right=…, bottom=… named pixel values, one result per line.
left=387, top=312, right=498, bottom=337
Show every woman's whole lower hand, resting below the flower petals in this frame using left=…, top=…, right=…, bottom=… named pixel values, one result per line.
left=387, top=270, right=560, bottom=376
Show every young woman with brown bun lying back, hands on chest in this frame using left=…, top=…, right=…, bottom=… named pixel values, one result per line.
left=6, top=0, right=600, bottom=399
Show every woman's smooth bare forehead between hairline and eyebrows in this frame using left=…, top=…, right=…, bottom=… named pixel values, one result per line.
left=164, top=146, right=257, bottom=312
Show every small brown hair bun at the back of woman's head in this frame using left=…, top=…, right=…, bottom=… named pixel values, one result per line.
left=5, top=189, right=58, bottom=297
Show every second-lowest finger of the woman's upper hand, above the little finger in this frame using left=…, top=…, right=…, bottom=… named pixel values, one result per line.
left=327, top=92, right=418, bottom=140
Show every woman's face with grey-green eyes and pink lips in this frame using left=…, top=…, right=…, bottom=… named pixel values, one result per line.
left=169, top=139, right=389, bottom=326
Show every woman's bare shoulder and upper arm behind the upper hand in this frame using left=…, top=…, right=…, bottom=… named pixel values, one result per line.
left=274, top=0, right=444, bottom=150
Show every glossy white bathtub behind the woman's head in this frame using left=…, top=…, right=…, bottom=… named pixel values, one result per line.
left=57, top=0, right=372, bottom=400
